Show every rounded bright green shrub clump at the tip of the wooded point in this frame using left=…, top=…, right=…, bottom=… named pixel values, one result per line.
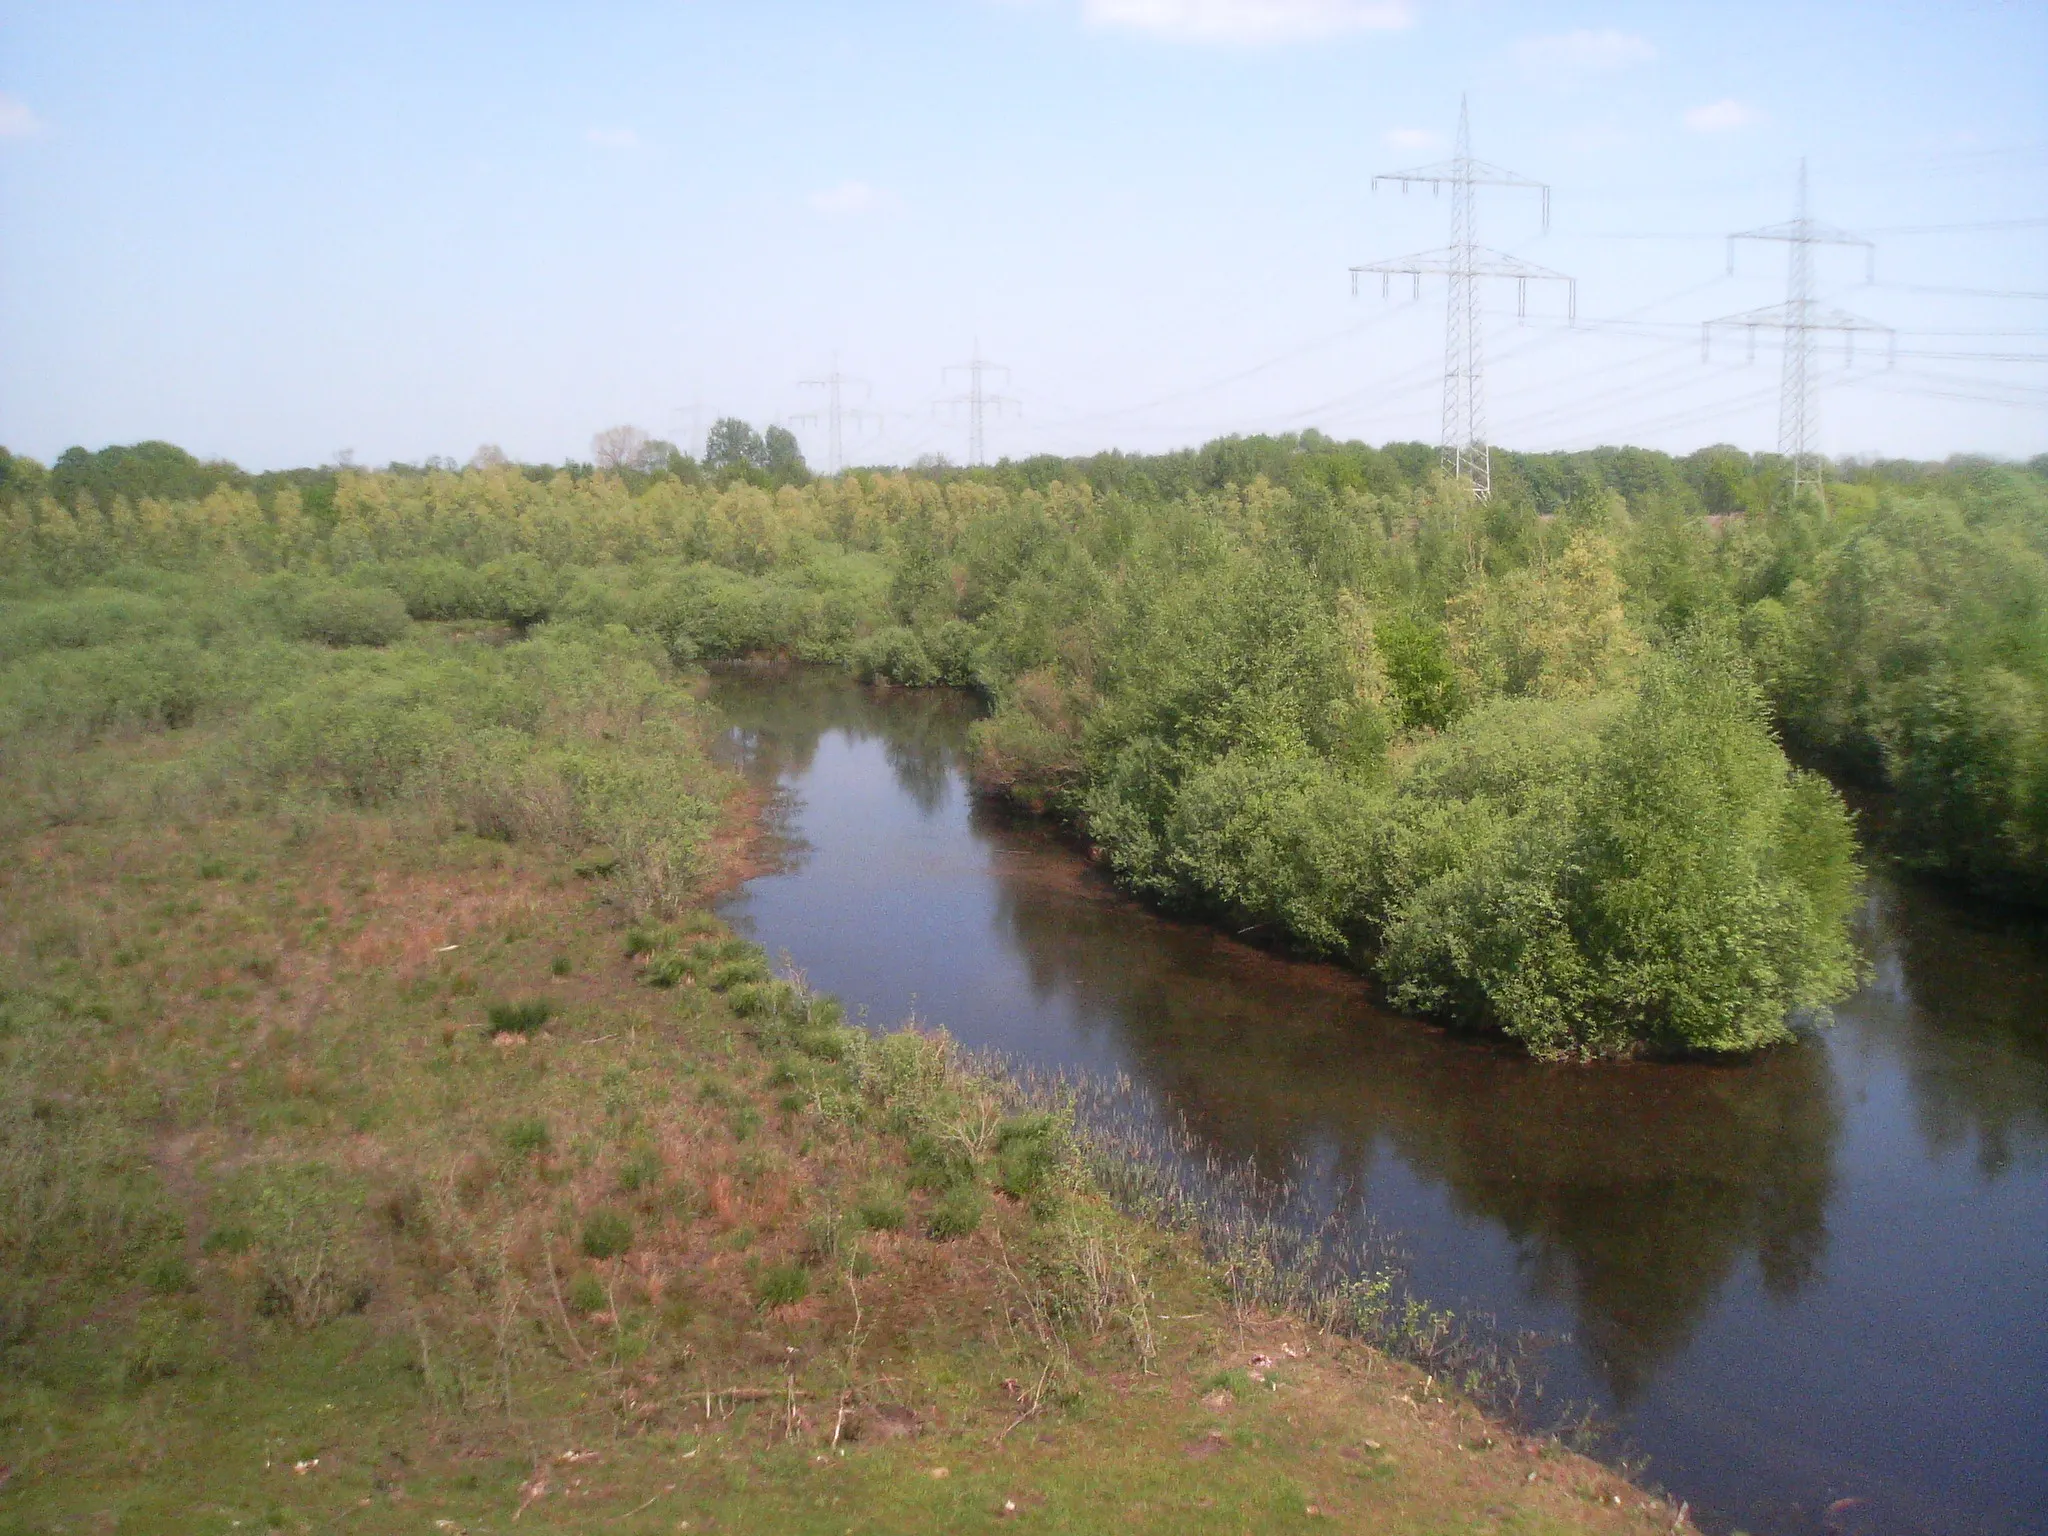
left=1376, top=633, right=1858, bottom=1055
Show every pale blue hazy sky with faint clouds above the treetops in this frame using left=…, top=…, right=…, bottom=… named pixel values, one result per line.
left=0, top=0, right=2048, bottom=467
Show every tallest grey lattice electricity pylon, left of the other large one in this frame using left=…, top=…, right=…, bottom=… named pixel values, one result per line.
left=1352, top=96, right=1579, bottom=500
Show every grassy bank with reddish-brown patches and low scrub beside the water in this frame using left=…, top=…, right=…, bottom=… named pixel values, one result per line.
left=0, top=621, right=1673, bottom=1532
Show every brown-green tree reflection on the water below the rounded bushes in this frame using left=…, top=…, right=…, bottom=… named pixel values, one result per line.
left=977, top=811, right=1839, bottom=1405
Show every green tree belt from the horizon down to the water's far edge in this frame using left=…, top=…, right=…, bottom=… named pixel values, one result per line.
left=0, top=434, right=2048, bottom=1057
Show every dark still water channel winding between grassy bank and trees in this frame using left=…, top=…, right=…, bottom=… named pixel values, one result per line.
left=713, top=672, right=2048, bottom=1536
